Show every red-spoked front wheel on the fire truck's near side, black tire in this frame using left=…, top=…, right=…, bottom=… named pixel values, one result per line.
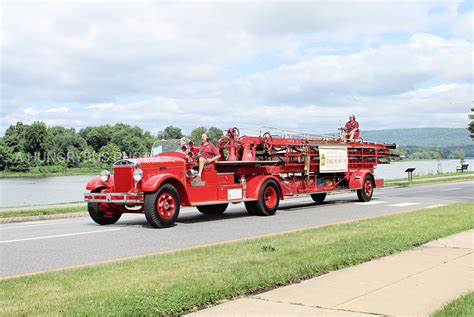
left=144, top=184, right=180, bottom=228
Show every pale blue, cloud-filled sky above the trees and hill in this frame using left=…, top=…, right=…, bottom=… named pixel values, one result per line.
left=0, top=0, right=474, bottom=134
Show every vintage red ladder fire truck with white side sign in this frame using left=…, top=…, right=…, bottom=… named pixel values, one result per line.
left=84, top=128, right=396, bottom=228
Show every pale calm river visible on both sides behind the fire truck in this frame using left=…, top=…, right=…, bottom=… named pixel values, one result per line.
left=0, top=159, right=474, bottom=207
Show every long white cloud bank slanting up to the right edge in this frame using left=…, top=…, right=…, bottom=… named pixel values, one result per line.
left=237, top=34, right=474, bottom=104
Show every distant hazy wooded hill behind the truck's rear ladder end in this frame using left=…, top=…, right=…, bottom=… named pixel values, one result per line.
left=361, top=128, right=474, bottom=148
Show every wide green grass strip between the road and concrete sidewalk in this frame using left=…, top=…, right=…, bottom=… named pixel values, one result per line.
left=0, top=203, right=474, bottom=316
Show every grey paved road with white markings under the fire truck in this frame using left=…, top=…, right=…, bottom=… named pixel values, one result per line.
left=0, top=181, right=474, bottom=277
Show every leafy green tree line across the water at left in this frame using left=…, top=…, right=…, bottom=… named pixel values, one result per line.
left=0, top=121, right=223, bottom=172
